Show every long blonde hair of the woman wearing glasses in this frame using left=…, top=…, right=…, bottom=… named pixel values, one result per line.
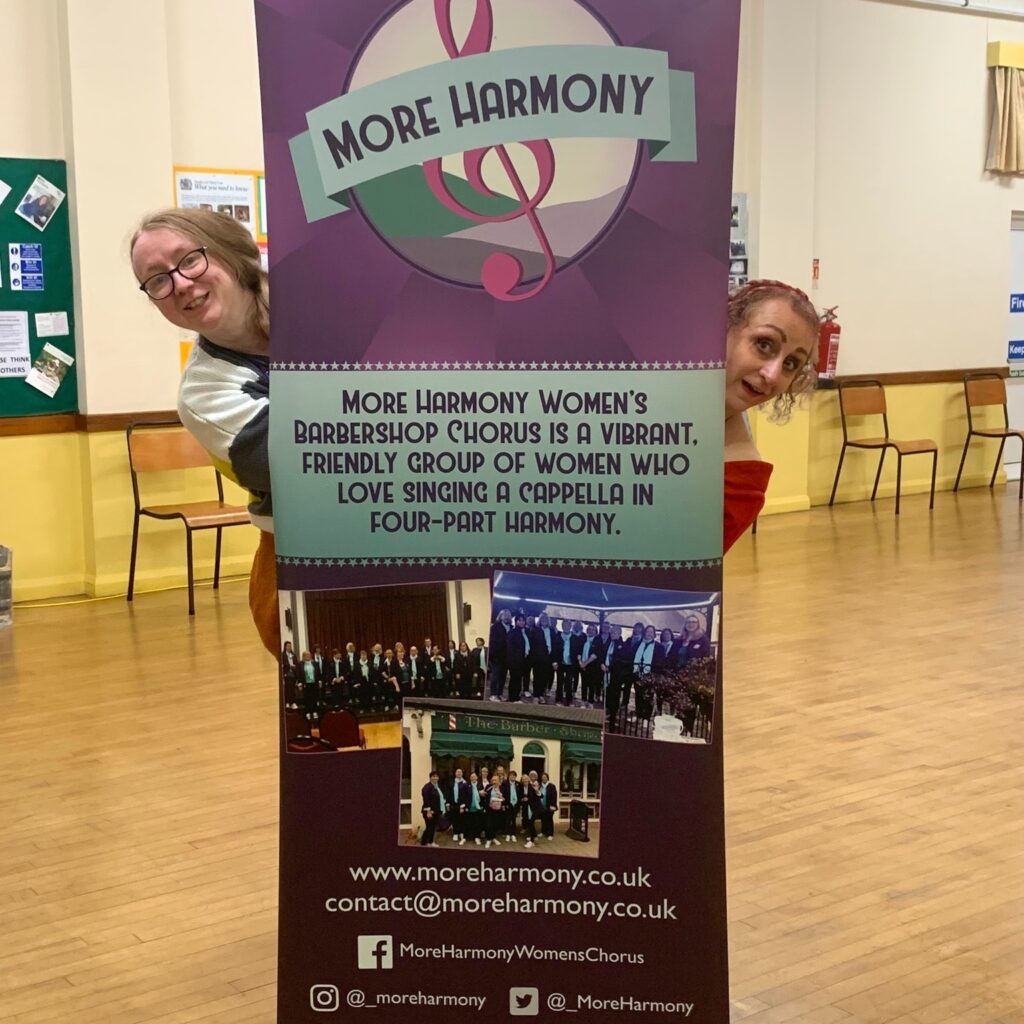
left=129, top=208, right=270, bottom=342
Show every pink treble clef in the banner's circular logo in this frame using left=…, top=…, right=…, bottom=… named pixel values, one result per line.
left=423, top=0, right=555, bottom=302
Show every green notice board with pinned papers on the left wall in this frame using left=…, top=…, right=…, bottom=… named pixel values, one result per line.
left=0, top=157, right=78, bottom=417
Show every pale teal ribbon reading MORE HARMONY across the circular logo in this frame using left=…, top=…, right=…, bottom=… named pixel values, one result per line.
left=290, top=46, right=696, bottom=221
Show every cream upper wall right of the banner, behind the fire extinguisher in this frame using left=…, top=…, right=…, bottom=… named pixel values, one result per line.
left=734, top=0, right=1024, bottom=373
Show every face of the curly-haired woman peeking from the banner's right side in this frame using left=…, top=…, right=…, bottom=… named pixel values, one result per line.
left=725, top=298, right=817, bottom=418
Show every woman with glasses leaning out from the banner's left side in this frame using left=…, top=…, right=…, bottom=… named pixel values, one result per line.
left=131, top=210, right=281, bottom=655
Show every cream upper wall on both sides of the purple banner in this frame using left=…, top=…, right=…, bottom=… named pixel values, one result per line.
left=8, top=0, right=1024, bottom=403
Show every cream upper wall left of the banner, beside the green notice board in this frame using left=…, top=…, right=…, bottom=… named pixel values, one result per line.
left=0, top=0, right=263, bottom=414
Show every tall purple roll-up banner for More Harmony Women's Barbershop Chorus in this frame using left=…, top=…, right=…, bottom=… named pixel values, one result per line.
left=256, top=0, right=739, bottom=1024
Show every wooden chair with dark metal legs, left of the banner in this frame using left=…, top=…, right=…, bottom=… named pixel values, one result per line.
left=127, top=420, right=249, bottom=615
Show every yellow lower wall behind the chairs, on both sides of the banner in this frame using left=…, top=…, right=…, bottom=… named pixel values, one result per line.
left=0, top=384, right=1007, bottom=601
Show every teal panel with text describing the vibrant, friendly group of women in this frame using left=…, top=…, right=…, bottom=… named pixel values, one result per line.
left=270, top=370, right=723, bottom=564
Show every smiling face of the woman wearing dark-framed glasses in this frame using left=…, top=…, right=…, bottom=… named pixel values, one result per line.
left=131, top=227, right=253, bottom=348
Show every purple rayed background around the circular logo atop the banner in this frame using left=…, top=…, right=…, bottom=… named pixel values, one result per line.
left=257, top=0, right=736, bottom=366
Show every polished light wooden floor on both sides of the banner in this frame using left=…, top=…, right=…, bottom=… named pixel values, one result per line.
left=0, top=487, right=1024, bottom=1024
